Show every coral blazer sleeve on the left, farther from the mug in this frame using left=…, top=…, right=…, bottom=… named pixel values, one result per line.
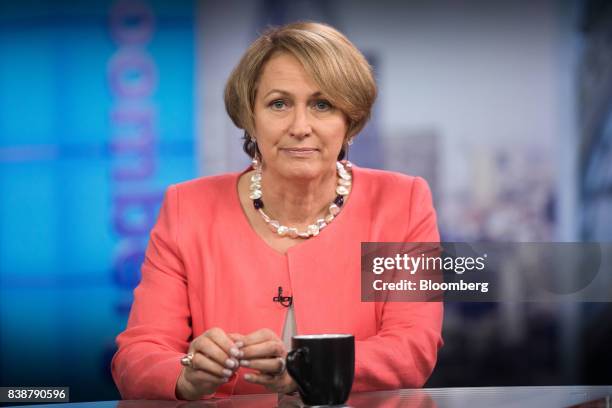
left=111, top=186, right=192, bottom=400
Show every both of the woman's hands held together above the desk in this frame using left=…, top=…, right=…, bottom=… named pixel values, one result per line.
left=176, top=328, right=296, bottom=400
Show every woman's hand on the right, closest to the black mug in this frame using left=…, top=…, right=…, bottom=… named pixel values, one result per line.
left=232, top=329, right=297, bottom=394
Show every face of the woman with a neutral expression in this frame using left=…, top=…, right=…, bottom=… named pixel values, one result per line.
left=254, top=53, right=347, bottom=179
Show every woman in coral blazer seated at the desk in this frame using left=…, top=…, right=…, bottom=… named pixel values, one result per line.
left=112, top=23, right=442, bottom=399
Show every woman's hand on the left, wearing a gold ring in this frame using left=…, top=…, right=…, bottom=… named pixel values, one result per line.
left=175, top=328, right=242, bottom=400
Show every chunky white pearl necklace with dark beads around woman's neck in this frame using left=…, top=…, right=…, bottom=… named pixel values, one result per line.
left=249, top=159, right=353, bottom=239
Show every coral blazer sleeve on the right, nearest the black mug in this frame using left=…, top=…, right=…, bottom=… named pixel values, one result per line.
left=353, top=178, right=443, bottom=392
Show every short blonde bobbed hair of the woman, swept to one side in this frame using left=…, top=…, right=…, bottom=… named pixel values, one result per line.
left=225, top=22, right=377, bottom=159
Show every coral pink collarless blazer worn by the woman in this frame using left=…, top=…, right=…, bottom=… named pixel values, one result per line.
left=112, top=166, right=443, bottom=399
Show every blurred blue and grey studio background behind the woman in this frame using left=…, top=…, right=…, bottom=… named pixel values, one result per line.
left=0, top=0, right=612, bottom=401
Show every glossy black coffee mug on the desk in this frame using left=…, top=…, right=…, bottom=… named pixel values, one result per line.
left=287, top=334, right=355, bottom=405
